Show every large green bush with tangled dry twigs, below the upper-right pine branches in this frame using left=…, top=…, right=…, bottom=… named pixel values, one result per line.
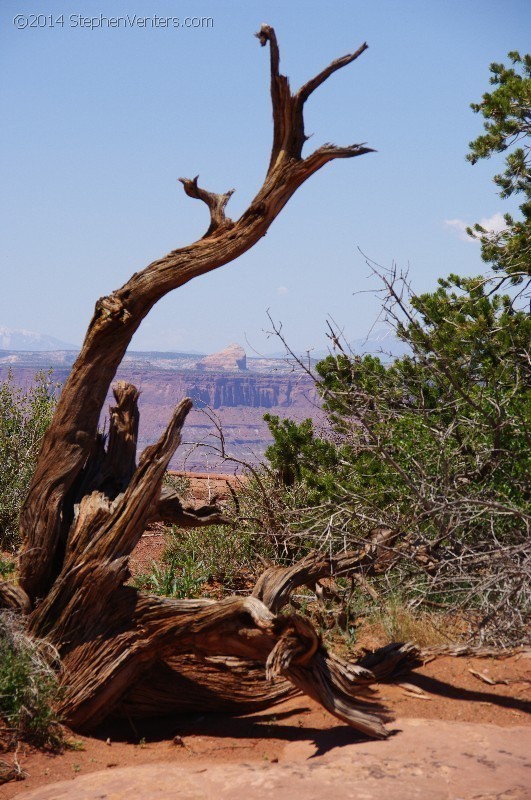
left=258, top=275, right=531, bottom=644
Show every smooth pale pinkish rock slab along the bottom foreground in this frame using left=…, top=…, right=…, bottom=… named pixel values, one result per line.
left=18, top=719, right=531, bottom=800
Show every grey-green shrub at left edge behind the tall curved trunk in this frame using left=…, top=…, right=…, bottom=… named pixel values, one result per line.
left=0, top=372, right=55, bottom=551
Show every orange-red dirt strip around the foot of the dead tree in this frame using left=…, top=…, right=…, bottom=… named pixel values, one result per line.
left=0, top=516, right=531, bottom=800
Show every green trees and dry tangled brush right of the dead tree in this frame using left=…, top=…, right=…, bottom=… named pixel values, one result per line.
left=156, top=53, right=531, bottom=646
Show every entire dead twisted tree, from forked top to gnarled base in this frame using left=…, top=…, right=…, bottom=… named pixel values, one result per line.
left=0, top=25, right=418, bottom=737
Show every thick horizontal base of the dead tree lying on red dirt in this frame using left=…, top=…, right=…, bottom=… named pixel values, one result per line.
left=51, top=587, right=389, bottom=738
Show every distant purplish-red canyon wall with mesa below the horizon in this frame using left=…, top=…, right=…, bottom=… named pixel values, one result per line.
left=0, top=354, right=323, bottom=472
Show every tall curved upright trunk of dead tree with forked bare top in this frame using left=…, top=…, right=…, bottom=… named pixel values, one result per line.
left=20, top=25, right=370, bottom=602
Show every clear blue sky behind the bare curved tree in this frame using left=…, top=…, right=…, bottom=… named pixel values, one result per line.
left=0, top=0, right=531, bottom=353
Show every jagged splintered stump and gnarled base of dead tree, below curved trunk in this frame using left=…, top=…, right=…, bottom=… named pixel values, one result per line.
left=17, top=388, right=387, bottom=737
